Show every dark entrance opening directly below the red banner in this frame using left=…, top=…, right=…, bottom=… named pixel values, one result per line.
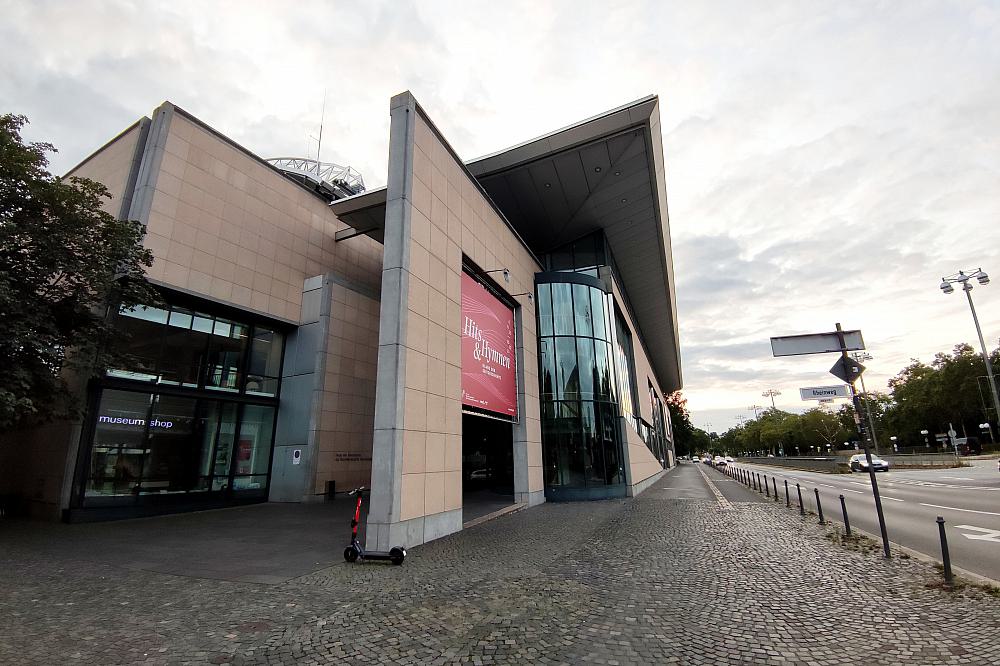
left=462, top=414, right=514, bottom=522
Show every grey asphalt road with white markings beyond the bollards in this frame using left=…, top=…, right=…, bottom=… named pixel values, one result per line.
left=706, top=460, right=1000, bottom=580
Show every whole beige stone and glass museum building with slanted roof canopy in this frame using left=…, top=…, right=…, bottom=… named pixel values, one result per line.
left=0, top=93, right=681, bottom=548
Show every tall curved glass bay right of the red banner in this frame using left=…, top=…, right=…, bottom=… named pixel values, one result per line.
left=536, top=274, right=625, bottom=499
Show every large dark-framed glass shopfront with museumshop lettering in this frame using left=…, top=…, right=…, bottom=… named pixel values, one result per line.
left=77, top=296, right=284, bottom=508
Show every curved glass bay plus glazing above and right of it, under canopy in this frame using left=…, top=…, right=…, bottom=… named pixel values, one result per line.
left=536, top=232, right=672, bottom=499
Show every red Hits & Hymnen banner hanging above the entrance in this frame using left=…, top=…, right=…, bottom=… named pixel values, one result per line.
left=462, top=273, right=517, bottom=417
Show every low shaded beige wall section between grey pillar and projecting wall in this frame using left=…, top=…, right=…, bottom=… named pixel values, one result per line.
left=311, top=280, right=379, bottom=495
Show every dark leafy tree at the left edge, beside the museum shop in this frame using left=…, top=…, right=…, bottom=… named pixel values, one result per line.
left=0, top=114, right=159, bottom=430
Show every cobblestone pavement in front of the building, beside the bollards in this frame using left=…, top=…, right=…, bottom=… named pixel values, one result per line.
left=0, top=465, right=1000, bottom=666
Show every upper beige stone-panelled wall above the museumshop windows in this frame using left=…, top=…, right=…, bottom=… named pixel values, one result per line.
left=145, top=111, right=382, bottom=321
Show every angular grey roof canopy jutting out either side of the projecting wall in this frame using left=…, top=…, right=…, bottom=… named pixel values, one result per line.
left=330, top=96, right=682, bottom=393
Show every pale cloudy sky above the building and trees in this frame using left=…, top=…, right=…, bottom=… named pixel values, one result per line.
left=0, top=0, right=1000, bottom=431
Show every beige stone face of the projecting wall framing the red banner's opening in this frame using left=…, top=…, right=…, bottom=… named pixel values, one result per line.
left=399, top=107, right=543, bottom=520
